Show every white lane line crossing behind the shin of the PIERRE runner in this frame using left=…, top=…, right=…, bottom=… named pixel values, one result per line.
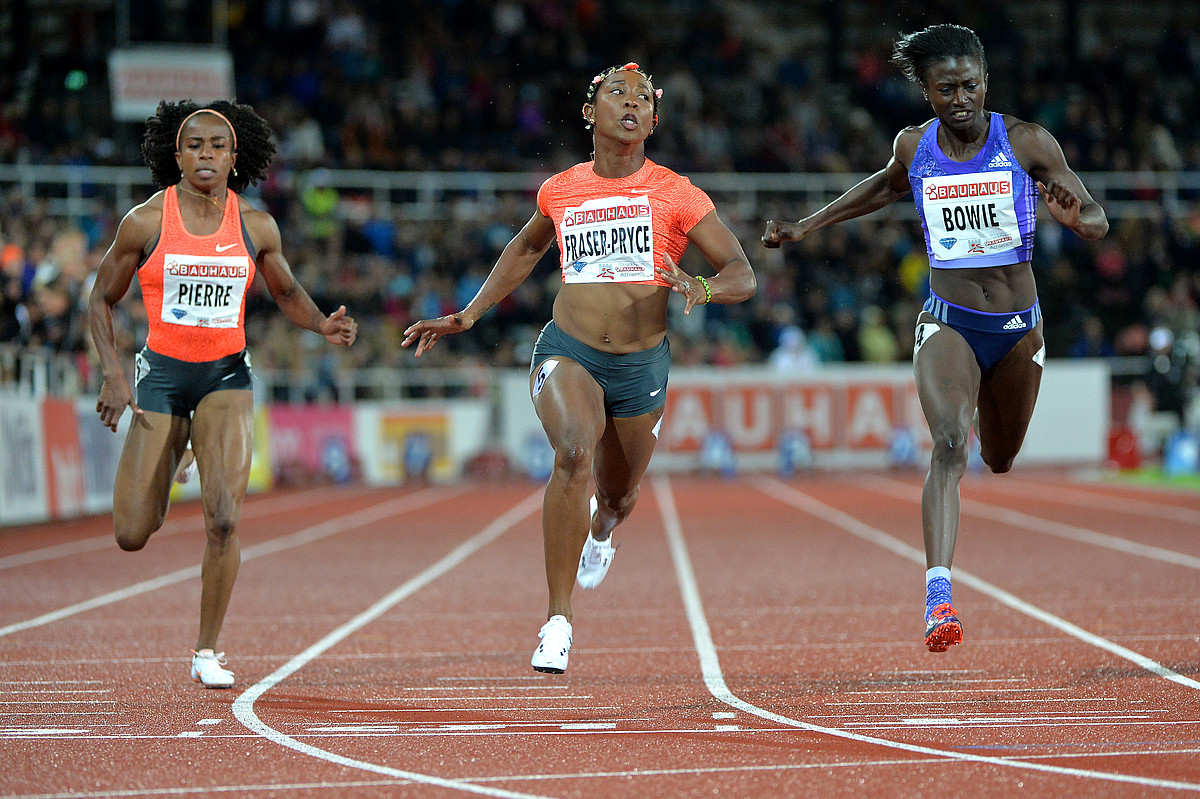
left=0, top=487, right=466, bottom=637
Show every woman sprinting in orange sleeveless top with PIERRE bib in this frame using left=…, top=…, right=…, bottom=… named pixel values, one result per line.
left=88, top=101, right=358, bottom=687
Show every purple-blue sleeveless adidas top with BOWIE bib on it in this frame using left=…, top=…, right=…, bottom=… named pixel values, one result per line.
left=908, top=112, right=1038, bottom=269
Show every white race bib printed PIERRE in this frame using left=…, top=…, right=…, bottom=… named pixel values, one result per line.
left=162, top=253, right=250, bottom=328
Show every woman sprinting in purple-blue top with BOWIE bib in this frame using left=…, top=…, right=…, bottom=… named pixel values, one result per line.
left=762, top=25, right=1109, bottom=651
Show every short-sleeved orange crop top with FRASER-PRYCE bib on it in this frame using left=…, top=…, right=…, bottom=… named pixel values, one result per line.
left=538, top=158, right=714, bottom=286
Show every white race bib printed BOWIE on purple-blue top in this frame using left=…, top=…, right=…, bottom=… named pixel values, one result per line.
left=922, top=172, right=1021, bottom=260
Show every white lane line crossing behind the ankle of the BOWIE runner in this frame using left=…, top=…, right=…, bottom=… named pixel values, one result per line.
left=750, top=477, right=1200, bottom=691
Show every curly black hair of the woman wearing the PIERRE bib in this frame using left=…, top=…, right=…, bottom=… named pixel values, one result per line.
left=142, top=100, right=275, bottom=192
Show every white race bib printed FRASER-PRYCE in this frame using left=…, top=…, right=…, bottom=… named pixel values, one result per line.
left=562, top=197, right=654, bottom=283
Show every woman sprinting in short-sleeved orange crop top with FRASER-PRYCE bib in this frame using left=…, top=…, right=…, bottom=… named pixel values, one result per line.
left=403, top=64, right=755, bottom=673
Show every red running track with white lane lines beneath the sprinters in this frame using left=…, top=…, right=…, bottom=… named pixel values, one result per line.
left=0, top=470, right=1200, bottom=799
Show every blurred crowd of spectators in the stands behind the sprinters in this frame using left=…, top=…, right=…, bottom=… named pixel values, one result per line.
left=0, top=0, right=1200, bottom=422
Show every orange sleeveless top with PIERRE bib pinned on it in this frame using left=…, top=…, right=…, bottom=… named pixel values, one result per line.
left=138, top=188, right=254, bottom=362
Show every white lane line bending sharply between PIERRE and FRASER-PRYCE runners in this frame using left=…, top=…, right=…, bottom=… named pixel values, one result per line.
left=233, top=488, right=559, bottom=799
